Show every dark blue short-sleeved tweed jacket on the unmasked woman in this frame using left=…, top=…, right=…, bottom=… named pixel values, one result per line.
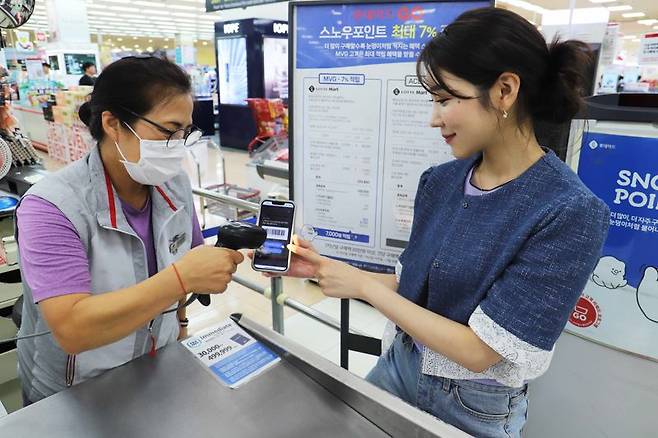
left=398, top=152, right=610, bottom=350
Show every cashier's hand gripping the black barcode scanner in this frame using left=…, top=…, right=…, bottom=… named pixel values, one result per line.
left=175, top=245, right=244, bottom=294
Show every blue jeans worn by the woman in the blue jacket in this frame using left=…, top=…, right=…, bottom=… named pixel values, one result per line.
left=366, top=332, right=528, bottom=438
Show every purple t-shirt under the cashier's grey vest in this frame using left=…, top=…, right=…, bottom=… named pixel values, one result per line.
left=16, top=195, right=203, bottom=303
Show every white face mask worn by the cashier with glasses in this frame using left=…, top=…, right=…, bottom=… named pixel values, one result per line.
left=114, top=123, right=185, bottom=186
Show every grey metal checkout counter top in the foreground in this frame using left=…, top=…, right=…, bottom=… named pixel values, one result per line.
left=0, top=315, right=468, bottom=438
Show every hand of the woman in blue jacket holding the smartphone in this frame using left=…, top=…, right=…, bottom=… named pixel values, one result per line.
left=288, top=244, right=372, bottom=299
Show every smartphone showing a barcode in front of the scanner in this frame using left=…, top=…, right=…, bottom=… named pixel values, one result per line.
left=251, top=199, right=295, bottom=272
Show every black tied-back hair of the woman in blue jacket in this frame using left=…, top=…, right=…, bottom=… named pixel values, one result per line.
left=417, top=8, right=593, bottom=124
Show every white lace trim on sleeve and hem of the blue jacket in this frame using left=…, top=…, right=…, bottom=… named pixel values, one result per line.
left=392, top=262, right=554, bottom=387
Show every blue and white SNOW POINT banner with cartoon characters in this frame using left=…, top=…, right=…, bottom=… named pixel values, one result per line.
left=567, top=132, right=658, bottom=359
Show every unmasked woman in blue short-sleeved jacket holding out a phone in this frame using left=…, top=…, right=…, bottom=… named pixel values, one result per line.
left=282, top=9, right=609, bottom=437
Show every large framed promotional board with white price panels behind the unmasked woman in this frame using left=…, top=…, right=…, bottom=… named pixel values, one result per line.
left=291, top=1, right=491, bottom=272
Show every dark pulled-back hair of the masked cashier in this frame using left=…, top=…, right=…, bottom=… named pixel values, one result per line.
left=79, top=57, right=192, bottom=142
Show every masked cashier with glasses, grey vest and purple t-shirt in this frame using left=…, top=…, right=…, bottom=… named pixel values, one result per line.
left=16, top=57, right=243, bottom=404
